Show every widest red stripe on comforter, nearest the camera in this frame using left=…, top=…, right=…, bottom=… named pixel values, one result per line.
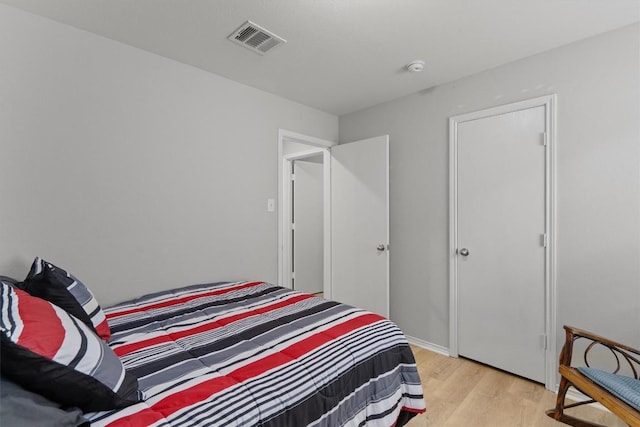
left=109, top=313, right=384, bottom=427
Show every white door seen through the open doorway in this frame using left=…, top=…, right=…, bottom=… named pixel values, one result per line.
left=291, top=154, right=324, bottom=293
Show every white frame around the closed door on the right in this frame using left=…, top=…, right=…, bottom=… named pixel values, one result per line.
left=449, top=94, right=557, bottom=390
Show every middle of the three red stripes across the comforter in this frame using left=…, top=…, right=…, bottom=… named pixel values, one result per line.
left=113, top=294, right=313, bottom=357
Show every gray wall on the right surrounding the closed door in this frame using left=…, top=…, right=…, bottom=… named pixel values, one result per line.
left=340, top=24, right=640, bottom=347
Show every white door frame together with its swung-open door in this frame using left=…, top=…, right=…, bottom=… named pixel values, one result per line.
left=278, top=130, right=389, bottom=317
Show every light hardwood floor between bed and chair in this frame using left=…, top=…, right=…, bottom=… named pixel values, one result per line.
left=407, top=346, right=626, bottom=427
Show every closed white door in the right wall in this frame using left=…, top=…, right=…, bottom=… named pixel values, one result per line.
left=457, top=106, right=546, bottom=383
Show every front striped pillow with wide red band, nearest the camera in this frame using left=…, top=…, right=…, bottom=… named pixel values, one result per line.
left=0, top=283, right=142, bottom=412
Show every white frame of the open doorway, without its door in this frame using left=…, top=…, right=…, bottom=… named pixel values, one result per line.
left=278, top=129, right=338, bottom=298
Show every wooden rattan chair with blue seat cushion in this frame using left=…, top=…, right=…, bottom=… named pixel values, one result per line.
left=546, top=326, right=640, bottom=427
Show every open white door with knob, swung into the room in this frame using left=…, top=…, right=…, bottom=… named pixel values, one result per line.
left=331, top=135, right=389, bottom=317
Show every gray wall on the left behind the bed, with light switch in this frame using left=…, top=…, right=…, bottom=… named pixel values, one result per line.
left=0, top=5, right=338, bottom=305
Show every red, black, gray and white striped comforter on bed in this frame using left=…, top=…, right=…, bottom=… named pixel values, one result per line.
left=88, top=282, right=425, bottom=427
